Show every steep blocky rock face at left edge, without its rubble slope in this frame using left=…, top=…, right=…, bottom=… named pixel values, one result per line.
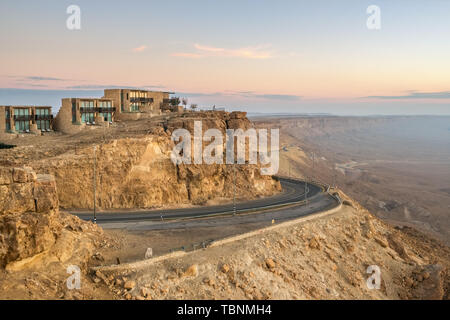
left=0, top=167, right=60, bottom=267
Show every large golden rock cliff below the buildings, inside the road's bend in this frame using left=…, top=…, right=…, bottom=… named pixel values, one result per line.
left=29, top=112, right=281, bottom=209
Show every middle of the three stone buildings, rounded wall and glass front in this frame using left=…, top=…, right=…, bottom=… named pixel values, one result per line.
left=54, top=98, right=116, bottom=133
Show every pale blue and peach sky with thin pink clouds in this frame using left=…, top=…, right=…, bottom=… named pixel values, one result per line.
left=0, top=0, right=450, bottom=115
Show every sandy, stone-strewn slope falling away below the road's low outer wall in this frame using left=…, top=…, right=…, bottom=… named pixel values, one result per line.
left=94, top=202, right=450, bottom=300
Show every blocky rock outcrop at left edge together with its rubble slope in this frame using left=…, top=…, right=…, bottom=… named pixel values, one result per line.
left=0, top=167, right=103, bottom=271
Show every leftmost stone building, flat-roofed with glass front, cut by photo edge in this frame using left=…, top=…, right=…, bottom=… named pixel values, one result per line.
left=0, top=106, right=53, bottom=134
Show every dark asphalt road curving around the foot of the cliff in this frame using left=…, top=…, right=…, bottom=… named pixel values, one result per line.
left=71, top=178, right=337, bottom=230
